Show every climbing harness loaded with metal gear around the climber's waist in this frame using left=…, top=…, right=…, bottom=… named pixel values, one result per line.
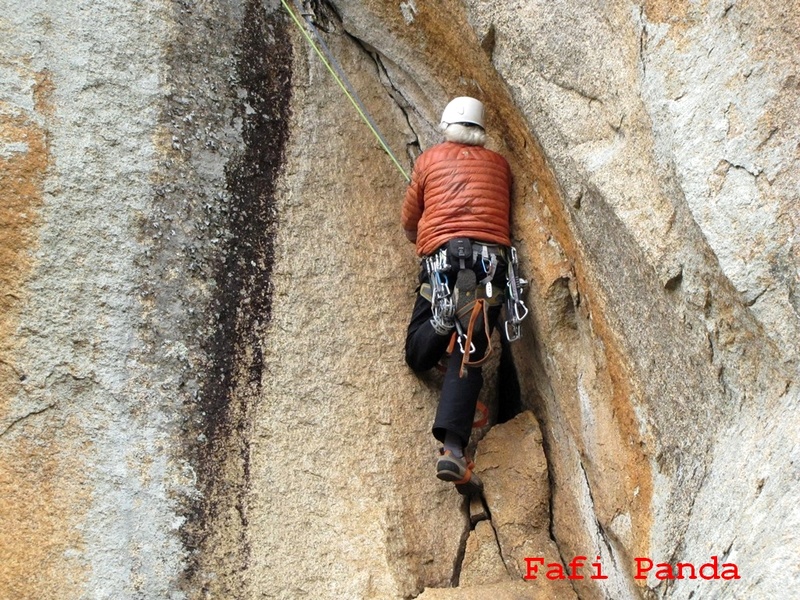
left=420, top=238, right=528, bottom=377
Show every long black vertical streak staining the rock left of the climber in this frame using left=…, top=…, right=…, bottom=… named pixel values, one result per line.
left=184, top=0, right=292, bottom=595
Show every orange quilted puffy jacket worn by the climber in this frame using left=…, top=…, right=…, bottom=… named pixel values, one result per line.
left=401, top=142, right=511, bottom=256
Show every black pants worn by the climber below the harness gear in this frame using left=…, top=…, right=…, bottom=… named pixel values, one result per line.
left=406, top=261, right=505, bottom=446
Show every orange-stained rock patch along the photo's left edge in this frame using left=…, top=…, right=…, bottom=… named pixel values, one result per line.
left=0, top=72, right=86, bottom=600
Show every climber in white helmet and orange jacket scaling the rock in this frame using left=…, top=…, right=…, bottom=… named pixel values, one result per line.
left=401, top=97, right=524, bottom=495
